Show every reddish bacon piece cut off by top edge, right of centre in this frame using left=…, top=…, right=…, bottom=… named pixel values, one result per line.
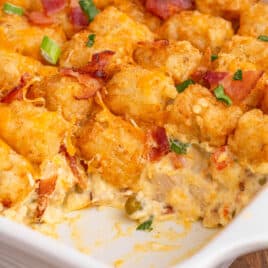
left=145, top=0, right=193, bottom=20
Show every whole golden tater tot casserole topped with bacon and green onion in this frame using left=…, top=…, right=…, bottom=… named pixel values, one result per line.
left=0, top=0, right=268, bottom=234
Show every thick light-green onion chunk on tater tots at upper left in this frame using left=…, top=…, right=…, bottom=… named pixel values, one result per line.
left=40, top=36, right=61, bottom=64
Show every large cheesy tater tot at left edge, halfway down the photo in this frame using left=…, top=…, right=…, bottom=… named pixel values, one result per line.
left=0, top=101, right=68, bottom=164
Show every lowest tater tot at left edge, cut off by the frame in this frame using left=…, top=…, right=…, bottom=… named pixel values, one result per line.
left=0, top=139, right=34, bottom=208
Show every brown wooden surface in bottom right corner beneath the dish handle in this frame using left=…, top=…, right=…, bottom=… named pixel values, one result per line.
left=230, top=250, right=268, bottom=268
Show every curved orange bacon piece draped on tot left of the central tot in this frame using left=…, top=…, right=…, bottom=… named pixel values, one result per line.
left=60, top=68, right=102, bottom=97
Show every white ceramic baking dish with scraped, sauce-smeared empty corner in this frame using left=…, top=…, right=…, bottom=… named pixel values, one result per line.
left=0, top=186, right=268, bottom=268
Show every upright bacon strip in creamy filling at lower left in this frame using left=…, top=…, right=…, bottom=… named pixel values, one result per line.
left=36, top=176, right=57, bottom=219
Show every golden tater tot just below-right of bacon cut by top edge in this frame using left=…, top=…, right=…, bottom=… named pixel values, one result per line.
left=160, top=11, right=233, bottom=52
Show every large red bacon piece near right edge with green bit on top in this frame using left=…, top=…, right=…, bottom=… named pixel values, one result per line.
left=204, top=71, right=263, bottom=104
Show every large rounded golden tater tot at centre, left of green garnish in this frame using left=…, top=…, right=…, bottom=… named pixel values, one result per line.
left=105, top=66, right=177, bottom=122
